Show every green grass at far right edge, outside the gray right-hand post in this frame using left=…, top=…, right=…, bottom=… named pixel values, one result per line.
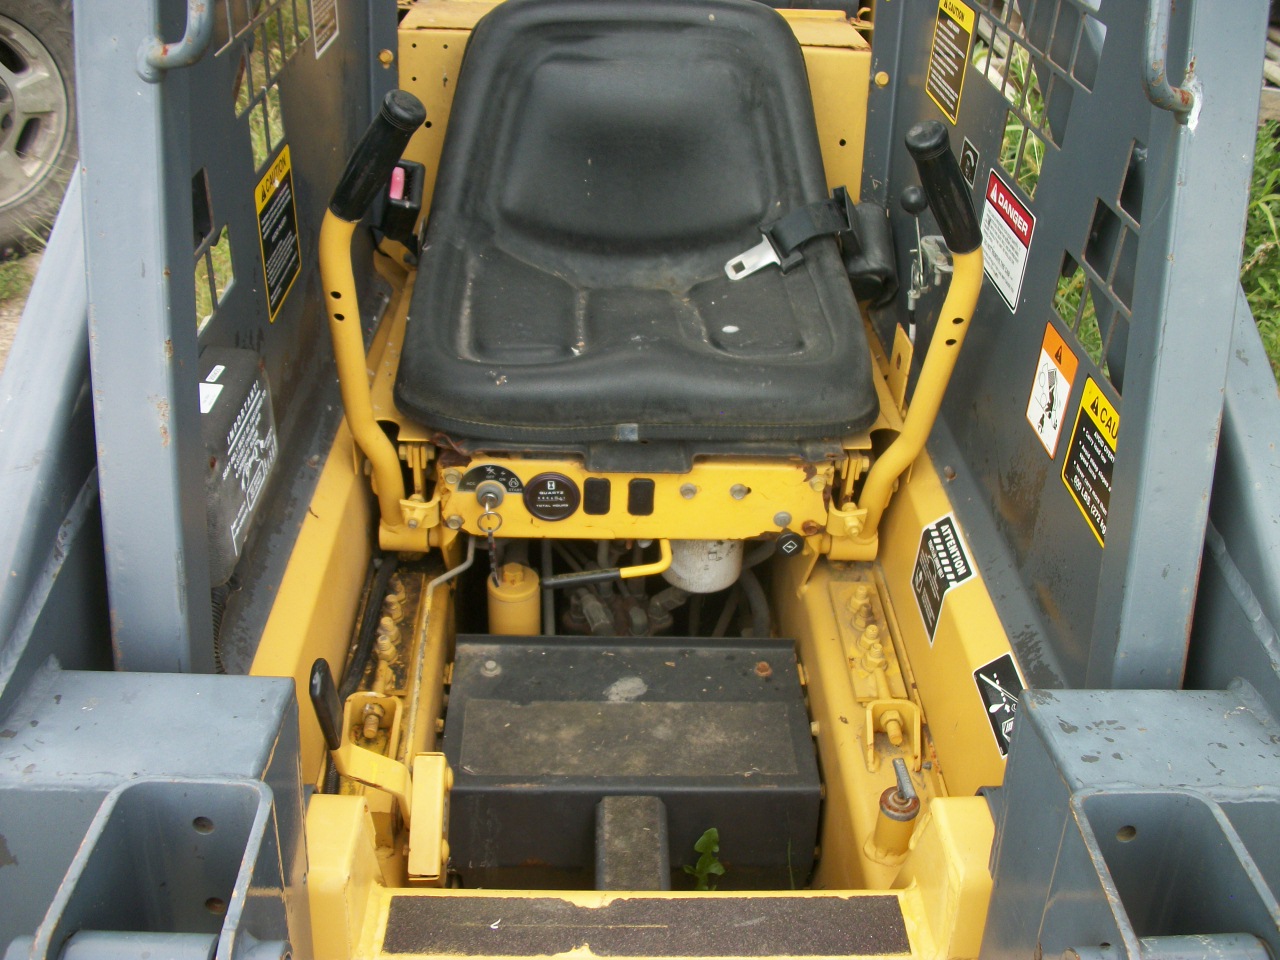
left=1240, top=120, right=1280, bottom=378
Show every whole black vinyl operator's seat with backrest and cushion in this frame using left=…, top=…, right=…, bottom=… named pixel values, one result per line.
left=396, top=0, right=878, bottom=445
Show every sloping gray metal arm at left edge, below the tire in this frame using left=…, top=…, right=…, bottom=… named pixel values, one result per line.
left=0, top=179, right=111, bottom=714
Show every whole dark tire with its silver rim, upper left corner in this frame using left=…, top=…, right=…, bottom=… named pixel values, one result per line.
left=0, top=0, right=77, bottom=260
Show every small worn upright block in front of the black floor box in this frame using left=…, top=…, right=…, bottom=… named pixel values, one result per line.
left=595, top=796, right=671, bottom=890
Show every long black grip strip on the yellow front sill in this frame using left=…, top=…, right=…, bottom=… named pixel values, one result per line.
left=383, top=896, right=910, bottom=957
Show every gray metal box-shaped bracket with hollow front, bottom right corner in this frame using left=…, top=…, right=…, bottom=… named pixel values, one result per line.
left=982, top=684, right=1280, bottom=960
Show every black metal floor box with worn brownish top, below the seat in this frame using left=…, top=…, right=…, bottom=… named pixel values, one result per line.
left=444, top=636, right=819, bottom=890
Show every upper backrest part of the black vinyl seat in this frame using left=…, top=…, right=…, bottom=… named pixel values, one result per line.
left=430, top=0, right=826, bottom=287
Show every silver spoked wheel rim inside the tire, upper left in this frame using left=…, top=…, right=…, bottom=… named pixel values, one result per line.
left=0, top=17, right=70, bottom=209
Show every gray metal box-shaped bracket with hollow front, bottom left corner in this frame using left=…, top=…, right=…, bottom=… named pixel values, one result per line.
left=0, top=667, right=311, bottom=960
